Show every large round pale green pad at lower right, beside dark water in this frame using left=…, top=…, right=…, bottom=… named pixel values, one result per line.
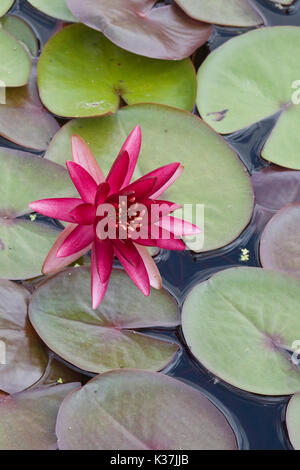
left=182, top=267, right=300, bottom=395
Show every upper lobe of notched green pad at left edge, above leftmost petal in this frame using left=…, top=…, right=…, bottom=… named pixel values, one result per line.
left=0, top=148, right=76, bottom=218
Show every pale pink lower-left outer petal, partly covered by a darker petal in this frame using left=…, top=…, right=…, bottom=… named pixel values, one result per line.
left=42, top=224, right=91, bottom=274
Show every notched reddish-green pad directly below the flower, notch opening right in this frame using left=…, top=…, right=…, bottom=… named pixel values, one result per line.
left=29, top=266, right=180, bottom=373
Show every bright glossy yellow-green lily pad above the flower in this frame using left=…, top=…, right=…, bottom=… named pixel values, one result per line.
left=38, top=24, right=196, bottom=117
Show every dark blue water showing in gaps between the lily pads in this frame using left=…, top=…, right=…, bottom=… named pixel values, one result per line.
left=6, top=0, right=300, bottom=449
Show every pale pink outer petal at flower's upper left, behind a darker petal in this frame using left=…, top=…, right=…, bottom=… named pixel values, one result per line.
left=72, top=135, right=105, bottom=184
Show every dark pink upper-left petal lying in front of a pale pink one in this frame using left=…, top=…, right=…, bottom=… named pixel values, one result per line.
left=66, top=161, right=98, bottom=204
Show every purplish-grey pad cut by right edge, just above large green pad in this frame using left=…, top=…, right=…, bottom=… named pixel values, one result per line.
left=260, top=204, right=300, bottom=277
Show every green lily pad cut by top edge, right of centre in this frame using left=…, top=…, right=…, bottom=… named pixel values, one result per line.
left=175, top=0, right=263, bottom=27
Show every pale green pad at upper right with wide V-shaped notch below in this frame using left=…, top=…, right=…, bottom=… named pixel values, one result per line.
left=197, top=26, right=300, bottom=169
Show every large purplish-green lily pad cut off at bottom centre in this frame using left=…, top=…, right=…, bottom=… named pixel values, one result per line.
left=56, top=370, right=237, bottom=450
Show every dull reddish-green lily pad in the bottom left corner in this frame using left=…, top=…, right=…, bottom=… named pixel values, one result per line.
left=0, top=383, right=80, bottom=450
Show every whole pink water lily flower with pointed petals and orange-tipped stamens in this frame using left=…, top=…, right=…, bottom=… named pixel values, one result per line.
left=30, top=126, right=200, bottom=309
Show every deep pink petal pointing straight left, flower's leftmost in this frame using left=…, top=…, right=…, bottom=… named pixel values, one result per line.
left=29, top=198, right=82, bottom=222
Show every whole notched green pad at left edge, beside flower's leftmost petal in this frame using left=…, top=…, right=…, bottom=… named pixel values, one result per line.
left=0, top=148, right=74, bottom=279
